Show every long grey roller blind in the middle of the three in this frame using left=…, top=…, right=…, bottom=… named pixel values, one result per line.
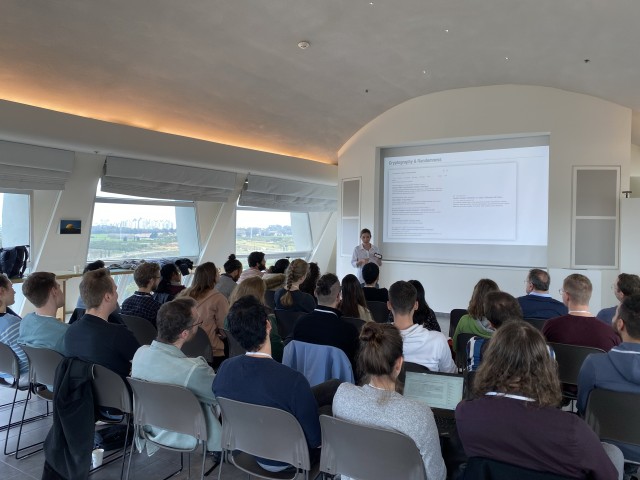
left=102, top=157, right=236, bottom=202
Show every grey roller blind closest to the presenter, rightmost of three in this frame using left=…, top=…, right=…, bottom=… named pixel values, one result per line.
left=238, top=175, right=338, bottom=212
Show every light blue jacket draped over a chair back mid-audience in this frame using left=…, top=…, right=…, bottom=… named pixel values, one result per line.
left=282, top=340, right=354, bottom=387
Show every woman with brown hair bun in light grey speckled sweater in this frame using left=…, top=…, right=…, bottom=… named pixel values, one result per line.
left=333, top=322, right=447, bottom=480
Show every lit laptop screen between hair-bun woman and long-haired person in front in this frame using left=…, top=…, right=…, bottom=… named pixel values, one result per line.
left=404, top=372, right=464, bottom=410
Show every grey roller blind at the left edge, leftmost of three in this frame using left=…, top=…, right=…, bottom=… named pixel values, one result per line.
left=0, top=140, right=74, bottom=190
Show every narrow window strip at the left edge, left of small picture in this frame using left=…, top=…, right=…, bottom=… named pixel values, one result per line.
left=0, top=192, right=31, bottom=247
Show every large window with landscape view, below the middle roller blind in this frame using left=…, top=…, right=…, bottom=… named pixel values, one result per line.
left=88, top=184, right=200, bottom=261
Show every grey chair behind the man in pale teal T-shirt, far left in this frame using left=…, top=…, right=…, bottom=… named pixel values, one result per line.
left=10, top=345, right=64, bottom=459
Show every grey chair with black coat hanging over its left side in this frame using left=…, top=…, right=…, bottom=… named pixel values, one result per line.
left=93, top=364, right=133, bottom=478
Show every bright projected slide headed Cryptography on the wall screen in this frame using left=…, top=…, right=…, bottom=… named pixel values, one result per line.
left=385, top=157, right=517, bottom=243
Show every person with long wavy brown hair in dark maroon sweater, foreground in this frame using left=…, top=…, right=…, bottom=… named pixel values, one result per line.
left=456, top=321, right=623, bottom=480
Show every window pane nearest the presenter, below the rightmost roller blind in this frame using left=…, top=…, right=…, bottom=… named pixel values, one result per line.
left=236, top=208, right=313, bottom=261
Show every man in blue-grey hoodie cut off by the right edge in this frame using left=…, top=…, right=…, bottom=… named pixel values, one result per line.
left=578, top=294, right=640, bottom=462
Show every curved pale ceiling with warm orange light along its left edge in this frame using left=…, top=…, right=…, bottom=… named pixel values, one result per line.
left=0, top=0, right=640, bottom=163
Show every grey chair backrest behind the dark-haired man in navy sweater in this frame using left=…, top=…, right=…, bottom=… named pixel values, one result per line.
left=218, top=397, right=311, bottom=470
